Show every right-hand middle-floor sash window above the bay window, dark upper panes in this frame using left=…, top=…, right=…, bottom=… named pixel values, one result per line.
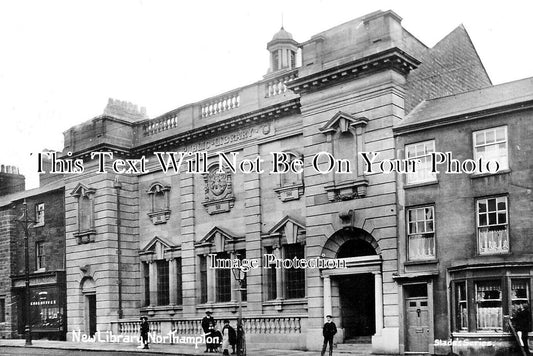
left=477, top=197, right=509, bottom=254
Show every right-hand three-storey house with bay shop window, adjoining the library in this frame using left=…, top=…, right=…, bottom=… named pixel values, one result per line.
left=394, top=78, right=533, bottom=356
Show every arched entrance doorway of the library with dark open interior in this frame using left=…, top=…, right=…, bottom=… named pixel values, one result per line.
left=322, top=228, right=383, bottom=343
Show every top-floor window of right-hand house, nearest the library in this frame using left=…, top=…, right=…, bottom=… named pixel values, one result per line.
left=405, top=140, right=437, bottom=184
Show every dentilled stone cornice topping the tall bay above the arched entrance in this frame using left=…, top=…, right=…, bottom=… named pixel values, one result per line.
left=287, top=47, right=420, bottom=94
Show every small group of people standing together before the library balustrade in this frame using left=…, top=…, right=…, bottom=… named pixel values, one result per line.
left=202, top=310, right=237, bottom=355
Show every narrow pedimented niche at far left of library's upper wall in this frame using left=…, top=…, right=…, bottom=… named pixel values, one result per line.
left=70, top=184, right=96, bottom=244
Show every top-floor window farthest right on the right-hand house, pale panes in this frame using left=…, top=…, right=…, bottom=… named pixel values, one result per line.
left=473, top=126, right=509, bottom=170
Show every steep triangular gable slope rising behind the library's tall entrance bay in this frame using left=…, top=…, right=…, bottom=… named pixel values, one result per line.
left=405, top=25, right=492, bottom=113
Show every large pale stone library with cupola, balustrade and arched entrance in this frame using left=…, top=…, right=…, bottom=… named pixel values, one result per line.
left=56, top=11, right=491, bottom=353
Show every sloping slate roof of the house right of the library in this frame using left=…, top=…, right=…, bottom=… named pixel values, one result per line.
left=397, top=77, right=533, bottom=127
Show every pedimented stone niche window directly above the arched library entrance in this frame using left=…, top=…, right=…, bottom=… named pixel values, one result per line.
left=320, top=111, right=368, bottom=201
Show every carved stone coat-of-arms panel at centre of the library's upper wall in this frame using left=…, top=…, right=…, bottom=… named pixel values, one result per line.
left=202, top=164, right=235, bottom=215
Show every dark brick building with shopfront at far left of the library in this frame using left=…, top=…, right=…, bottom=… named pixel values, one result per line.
left=0, top=174, right=66, bottom=340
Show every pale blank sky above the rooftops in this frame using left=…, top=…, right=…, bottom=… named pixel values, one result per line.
left=0, top=0, right=533, bottom=188
